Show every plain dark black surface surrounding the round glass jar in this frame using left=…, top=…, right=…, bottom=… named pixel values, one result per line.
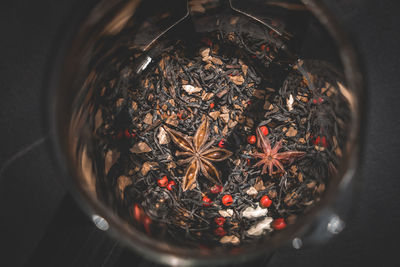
left=0, top=0, right=400, bottom=267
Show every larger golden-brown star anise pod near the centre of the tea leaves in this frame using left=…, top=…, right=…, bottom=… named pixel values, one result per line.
left=165, top=119, right=232, bottom=191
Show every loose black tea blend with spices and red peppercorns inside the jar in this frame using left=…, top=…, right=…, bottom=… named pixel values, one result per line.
left=91, top=21, right=349, bottom=249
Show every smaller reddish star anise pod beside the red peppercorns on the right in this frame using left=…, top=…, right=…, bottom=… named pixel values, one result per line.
left=252, top=128, right=306, bottom=176
